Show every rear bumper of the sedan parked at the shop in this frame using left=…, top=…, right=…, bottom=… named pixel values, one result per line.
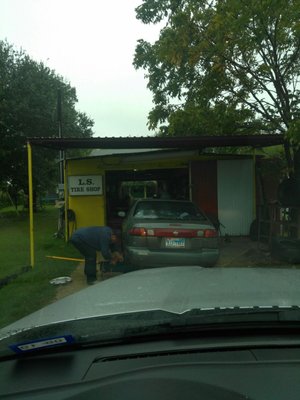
left=126, top=247, right=220, bottom=268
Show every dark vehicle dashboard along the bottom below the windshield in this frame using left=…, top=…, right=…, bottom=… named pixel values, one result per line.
left=0, top=334, right=300, bottom=400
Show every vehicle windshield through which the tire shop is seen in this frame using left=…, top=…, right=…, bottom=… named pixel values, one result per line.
left=0, top=0, right=300, bottom=364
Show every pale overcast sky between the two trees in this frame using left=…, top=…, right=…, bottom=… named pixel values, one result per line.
left=0, top=0, right=159, bottom=137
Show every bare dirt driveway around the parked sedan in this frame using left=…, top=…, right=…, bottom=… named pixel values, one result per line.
left=56, top=237, right=281, bottom=300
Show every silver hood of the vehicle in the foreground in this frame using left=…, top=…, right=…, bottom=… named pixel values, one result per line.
left=0, top=267, right=300, bottom=339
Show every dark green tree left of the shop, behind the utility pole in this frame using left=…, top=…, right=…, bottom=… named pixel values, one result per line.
left=0, top=41, right=93, bottom=203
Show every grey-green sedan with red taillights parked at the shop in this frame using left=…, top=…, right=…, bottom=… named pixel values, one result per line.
left=122, top=199, right=219, bottom=268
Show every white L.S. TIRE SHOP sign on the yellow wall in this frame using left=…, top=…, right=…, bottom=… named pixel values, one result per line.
left=68, top=175, right=103, bottom=196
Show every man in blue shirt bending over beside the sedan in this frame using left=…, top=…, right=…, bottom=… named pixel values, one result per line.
left=70, top=226, right=123, bottom=285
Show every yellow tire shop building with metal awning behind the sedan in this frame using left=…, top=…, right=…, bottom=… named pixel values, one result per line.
left=28, top=135, right=284, bottom=260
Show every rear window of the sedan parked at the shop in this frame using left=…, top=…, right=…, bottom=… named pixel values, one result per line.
left=133, top=201, right=206, bottom=221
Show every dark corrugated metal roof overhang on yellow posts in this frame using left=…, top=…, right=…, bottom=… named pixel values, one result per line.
left=28, top=134, right=284, bottom=150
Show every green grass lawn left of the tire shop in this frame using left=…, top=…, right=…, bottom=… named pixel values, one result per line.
left=0, top=206, right=80, bottom=327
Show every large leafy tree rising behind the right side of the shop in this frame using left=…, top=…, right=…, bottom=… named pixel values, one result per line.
left=134, top=0, right=300, bottom=163
